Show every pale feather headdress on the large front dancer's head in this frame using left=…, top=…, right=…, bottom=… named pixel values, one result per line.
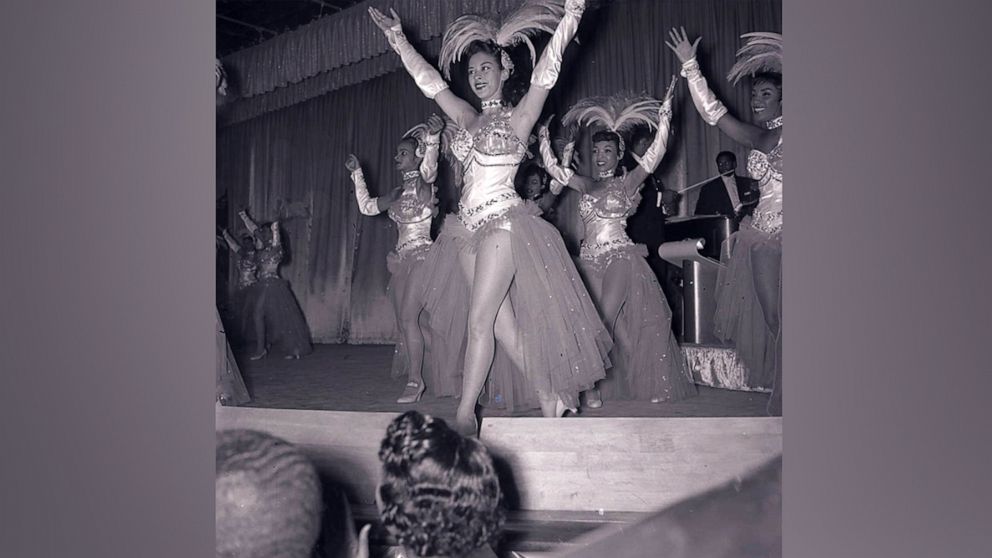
left=438, top=0, right=565, bottom=79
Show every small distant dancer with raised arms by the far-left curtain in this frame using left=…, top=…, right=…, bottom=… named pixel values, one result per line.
left=238, top=211, right=313, bottom=360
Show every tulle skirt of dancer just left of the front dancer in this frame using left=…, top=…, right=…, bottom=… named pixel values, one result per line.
left=386, top=244, right=467, bottom=397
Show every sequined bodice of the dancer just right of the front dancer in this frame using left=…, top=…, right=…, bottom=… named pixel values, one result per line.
left=579, top=177, right=641, bottom=258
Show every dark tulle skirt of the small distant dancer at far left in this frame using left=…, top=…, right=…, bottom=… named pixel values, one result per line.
left=256, top=277, right=313, bottom=356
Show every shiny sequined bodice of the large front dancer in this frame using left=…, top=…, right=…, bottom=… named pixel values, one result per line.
left=451, top=107, right=527, bottom=231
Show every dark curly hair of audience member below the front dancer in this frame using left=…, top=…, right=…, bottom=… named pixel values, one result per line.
left=379, top=411, right=505, bottom=557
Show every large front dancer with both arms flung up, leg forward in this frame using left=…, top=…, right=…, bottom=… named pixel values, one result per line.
left=369, top=0, right=612, bottom=434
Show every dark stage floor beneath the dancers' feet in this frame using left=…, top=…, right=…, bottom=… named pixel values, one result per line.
left=235, top=345, right=768, bottom=420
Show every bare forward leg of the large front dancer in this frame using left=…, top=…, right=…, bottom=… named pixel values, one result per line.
left=455, top=231, right=515, bottom=432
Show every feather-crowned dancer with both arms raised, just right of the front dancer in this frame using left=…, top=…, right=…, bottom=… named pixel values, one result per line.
left=539, top=86, right=696, bottom=408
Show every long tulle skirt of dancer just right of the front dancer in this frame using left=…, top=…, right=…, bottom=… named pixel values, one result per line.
left=578, top=244, right=696, bottom=401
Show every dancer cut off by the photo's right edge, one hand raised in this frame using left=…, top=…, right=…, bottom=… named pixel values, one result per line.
left=666, top=29, right=782, bottom=414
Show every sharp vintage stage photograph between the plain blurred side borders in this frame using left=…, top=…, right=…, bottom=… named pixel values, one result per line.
left=215, top=0, right=784, bottom=558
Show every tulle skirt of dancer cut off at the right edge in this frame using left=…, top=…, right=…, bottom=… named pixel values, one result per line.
left=714, top=225, right=782, bottom=406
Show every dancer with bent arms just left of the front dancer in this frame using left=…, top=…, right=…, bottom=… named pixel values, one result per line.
left=345, top=115, right=457, bottom=403
